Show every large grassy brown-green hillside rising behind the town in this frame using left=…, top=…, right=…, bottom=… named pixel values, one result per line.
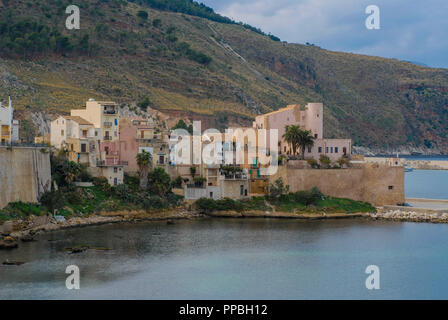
left=0, top=0, right=448, bottom=154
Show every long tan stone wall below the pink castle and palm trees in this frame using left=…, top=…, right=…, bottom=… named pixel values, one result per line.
left=270, top=164, right=405, bottom=206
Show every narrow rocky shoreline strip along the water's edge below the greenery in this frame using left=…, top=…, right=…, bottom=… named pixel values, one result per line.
left=0, top=207, right=448, bottom=249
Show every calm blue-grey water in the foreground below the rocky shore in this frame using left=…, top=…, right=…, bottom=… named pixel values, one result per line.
left=0, top=219, right=448, bottom=299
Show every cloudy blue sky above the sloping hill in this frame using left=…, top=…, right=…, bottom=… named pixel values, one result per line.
left=203, top=0, right=448, bottom=68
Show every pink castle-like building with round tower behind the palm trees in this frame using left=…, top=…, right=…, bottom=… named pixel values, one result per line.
left=253, top=103, right=352, bottom=161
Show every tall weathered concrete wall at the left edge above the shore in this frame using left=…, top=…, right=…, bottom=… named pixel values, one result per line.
left=0, top=147, right=51, bottom=208
